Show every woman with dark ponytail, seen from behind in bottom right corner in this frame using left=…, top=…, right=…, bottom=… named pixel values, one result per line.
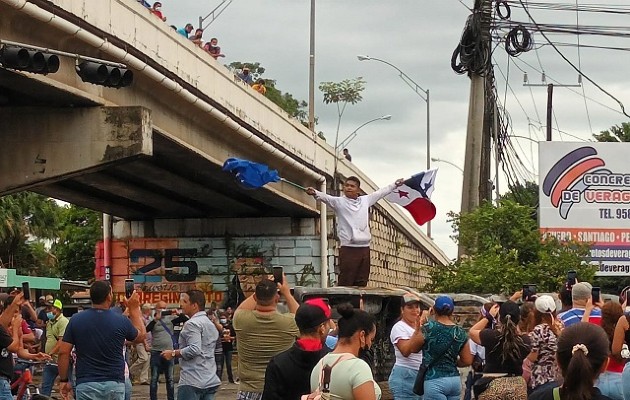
left=529, top=322, right=610, bottom=400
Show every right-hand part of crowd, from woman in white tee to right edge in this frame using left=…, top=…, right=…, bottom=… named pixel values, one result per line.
left=389, top=282, right=630, bottom=400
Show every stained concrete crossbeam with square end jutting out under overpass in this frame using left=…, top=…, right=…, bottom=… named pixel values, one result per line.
left=0, top=107, right=153, bottom=195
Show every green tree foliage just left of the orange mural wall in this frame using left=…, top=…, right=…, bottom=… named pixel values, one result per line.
left=52, top=205, right=102, bottom=280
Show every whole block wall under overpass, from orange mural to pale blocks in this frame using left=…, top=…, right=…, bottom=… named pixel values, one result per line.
left=102, top=218, right=321, bottom=303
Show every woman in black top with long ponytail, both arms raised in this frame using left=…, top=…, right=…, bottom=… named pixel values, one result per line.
left=469, top=301, right=530, bottom=400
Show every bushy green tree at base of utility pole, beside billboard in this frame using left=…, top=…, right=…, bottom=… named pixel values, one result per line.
left=426, top=199, right=595, bottom=293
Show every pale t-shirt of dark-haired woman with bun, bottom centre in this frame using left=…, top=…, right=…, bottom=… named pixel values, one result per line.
left=311, top=353, right=381, bottom=400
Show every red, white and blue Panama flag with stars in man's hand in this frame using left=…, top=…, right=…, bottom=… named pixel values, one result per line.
left=385, top=169, right=437, bottom=225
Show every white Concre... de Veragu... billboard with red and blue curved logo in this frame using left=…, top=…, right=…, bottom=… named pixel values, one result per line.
left=539, top=142, right=630, bottom=276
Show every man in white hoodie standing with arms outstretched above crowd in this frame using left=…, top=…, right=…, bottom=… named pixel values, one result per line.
left=306, top=176, right=404, bottom=286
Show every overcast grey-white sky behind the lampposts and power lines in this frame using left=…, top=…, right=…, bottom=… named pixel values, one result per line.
left=162, top=0, right=630, bottom=258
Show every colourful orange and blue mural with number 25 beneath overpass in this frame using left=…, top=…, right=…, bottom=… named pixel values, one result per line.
left=96, top=238, right=273, bottom=305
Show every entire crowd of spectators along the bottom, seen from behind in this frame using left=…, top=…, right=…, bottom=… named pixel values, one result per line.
left=0, top=277, right=630, bottom=400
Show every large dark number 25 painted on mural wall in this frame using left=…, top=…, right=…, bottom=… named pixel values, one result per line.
left=129, top=249, right=199, bottom=282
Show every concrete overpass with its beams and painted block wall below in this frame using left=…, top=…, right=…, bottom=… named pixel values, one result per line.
left=0, top=0, right=448, bottom=300
